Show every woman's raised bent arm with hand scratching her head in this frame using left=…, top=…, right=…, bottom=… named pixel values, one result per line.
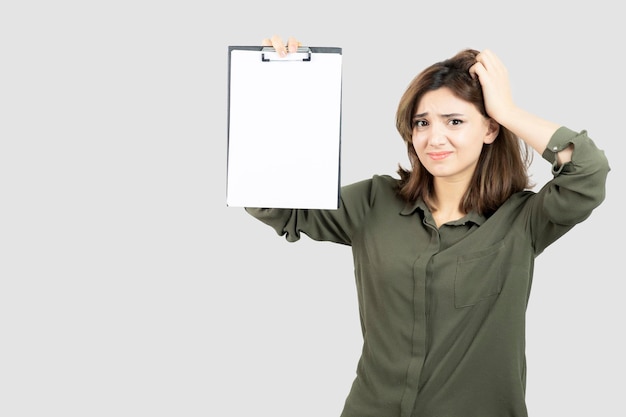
left=469, top=50, right=610, bottom=231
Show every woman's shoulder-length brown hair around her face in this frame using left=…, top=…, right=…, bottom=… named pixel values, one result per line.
left=396, top=49, right=533, bottom=216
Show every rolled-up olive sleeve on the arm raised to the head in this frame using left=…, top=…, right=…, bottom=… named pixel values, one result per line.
left=533, top=127, right=610, bottom=252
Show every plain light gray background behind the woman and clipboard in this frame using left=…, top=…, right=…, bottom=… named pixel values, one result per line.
left=0, top=0, right=626, bottom=417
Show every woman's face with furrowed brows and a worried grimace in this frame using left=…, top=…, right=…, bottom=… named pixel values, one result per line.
left=413, top=87, right=498, bottom=183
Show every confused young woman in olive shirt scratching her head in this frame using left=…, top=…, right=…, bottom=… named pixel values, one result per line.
left=246, top=38, right=609, bottom=417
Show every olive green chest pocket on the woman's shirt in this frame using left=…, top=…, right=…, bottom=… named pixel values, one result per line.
left=454, top=237, right=504, bottom=308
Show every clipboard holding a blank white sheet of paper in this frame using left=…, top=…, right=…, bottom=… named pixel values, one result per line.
left=226, top=46, right=342, bottom=209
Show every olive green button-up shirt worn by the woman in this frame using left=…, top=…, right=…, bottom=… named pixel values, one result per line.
left=246, top=127, right=609, bottom=417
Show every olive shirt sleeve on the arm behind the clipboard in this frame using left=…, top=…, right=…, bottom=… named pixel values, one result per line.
left=245, top=175, right=380, bottom=245
